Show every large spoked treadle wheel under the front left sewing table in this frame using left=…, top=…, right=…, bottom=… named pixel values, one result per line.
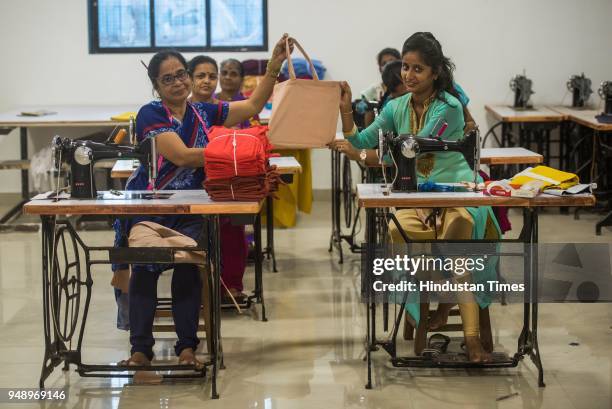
left=50, top=226, right=85, bottom=342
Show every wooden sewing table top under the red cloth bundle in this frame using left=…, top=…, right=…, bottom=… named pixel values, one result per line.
left=23, top=190, right=262, bottom=215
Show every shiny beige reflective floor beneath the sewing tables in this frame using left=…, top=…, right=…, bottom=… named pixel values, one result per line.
left=0, top=196, right=612, bottom=409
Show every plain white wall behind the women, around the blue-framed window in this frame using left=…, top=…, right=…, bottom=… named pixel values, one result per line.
left=0, top=0, right=612, bottom=192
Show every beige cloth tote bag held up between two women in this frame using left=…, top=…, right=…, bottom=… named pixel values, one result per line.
left=268, top=39, right=340, bottom=149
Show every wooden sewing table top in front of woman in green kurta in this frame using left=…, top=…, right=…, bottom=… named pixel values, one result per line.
left=357, top=183, right=595, bottom=208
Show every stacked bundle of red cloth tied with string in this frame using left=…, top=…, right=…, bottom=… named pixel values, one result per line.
left=204, top=126, right=280, bottom=201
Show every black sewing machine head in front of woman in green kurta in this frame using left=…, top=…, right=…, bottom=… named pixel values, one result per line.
left=380, top=129, right=480, bottom=192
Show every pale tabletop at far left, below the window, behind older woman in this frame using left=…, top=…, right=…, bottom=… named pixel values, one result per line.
left=0, top=105, right=139, bottom=127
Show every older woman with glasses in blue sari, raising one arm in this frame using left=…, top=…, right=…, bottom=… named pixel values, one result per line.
left=115, top=34, right=293, bottom=367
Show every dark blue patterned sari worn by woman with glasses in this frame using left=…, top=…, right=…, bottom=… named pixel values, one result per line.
left=112, top=101, right=229, bottom=329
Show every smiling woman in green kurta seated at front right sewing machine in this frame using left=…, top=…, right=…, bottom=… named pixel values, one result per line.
left=331, top=33, right=500, bottom=362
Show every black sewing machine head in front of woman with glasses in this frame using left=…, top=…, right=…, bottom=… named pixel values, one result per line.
left=51, top=136, right=157, bottom=199
